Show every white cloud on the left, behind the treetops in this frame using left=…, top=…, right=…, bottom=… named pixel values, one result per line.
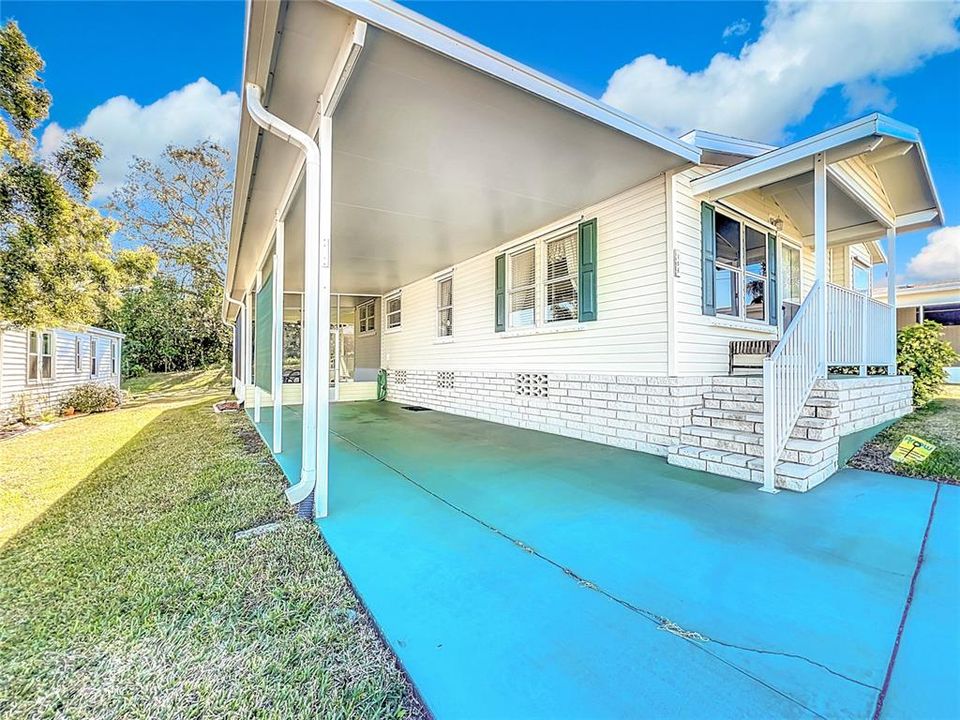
left=40, top=77, right=240, bottom=199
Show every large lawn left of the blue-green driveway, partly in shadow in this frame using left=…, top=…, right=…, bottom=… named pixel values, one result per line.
left=0, top=375, right=423, bottom=720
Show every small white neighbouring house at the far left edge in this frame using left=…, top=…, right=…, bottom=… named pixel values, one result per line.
left=0, top=327, right=123, bottom=422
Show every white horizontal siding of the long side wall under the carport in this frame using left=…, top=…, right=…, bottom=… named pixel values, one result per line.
left=383, top=177, right=667, bottom=375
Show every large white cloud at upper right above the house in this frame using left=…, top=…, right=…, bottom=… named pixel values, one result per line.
left=603, top=2, right=960, bottom=142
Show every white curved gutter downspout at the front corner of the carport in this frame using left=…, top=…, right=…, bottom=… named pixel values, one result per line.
left=246, top=83, right=330, bottom=514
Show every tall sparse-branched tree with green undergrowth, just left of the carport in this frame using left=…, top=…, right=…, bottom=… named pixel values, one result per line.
left=108, top=141, right=232, bottom=372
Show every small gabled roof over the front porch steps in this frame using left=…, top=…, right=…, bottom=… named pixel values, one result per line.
left=692, top=114, right=943, bottom=244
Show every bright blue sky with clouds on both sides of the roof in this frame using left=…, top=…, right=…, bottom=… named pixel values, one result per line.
left=7, top=0, right=960, bottom=282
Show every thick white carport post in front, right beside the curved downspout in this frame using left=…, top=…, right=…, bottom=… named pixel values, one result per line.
left=313, top=114, right=333, bottom=518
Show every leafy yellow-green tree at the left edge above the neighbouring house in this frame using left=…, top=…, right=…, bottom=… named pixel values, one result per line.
left=0, top=21, right=132, bottom=326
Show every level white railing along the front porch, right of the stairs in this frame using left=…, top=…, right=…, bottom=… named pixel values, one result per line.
left=826, top=283, right=896, bottom=368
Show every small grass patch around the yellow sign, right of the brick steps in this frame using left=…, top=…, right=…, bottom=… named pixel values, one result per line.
left=849, top=385, right=960, bottom=483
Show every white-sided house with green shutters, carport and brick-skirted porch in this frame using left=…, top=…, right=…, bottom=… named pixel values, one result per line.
left=224, top=0, right=943, bottom=516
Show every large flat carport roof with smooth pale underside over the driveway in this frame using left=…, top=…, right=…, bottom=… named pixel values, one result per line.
left=225, top=0, right=700, bottom=316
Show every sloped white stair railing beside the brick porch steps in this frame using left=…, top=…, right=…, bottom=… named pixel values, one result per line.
left=763, top=280, right=826, bottom=492
